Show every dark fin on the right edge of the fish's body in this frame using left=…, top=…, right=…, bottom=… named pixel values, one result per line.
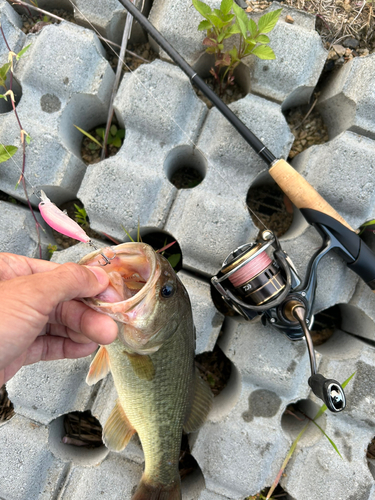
left=184, top=369, right=214, bottom=433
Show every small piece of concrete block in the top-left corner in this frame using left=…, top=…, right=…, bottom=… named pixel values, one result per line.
left=0, top=0, right=26, bottom=66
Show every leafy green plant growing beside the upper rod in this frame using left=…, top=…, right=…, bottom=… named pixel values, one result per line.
left=193, top=0, right=282, bottom=94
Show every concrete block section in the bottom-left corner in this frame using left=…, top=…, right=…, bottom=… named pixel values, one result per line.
left=0, top=415, right=66, bottom=500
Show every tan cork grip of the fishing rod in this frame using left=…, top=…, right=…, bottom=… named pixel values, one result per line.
left=269, top=159, right=353, bottom=231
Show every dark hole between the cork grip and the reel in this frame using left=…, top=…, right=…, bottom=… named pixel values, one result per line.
left=246, top=176, right=293, bottom=237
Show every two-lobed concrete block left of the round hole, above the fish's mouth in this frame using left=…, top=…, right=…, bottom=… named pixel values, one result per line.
left=78, top=61, right=206, bottom=241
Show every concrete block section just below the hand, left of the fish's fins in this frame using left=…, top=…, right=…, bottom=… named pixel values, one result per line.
left=7, top=357, right=93, bottom=424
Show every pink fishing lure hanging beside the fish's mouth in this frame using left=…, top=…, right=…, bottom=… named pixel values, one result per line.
left=39, top=191, right=90, bottom=243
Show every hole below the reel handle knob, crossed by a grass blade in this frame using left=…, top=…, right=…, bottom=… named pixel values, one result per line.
left=281, top=399, right=327, bottom=446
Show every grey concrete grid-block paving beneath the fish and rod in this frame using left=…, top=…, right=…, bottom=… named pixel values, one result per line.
left=0, top=0, right=375, bottom=500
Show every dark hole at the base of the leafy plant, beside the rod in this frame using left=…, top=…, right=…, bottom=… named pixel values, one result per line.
left=193, top=53, right=250, bottom=108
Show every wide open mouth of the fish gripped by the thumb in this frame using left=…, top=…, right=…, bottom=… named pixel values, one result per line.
left=79, top=243, right=160, bottom=321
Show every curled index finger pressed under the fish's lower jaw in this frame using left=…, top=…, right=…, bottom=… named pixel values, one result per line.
left=50, top=300, right=117, bottom=344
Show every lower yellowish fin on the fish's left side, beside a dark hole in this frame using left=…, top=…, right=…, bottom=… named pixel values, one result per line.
left=103, top=401, right=135, bottom=451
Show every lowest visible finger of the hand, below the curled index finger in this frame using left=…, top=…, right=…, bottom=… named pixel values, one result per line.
left=24, top=335, right=98, bottom=365
